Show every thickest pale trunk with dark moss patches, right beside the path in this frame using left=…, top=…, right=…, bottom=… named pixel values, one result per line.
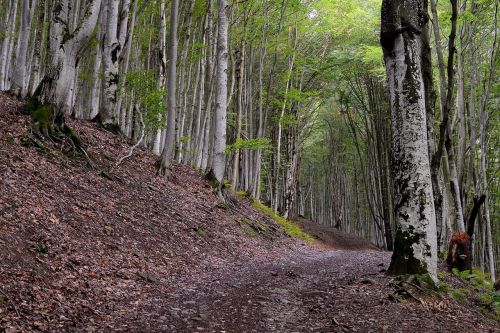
left=381, top=0, right=437, bottom=280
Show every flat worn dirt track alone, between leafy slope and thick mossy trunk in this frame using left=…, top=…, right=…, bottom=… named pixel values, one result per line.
left=165, top=250, right=389, bottom=332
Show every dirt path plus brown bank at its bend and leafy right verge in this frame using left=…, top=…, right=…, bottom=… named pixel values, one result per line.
left=120, top=220, right=498, bottom=333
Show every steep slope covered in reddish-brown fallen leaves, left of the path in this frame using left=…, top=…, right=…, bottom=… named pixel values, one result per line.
left=0, top=94, right=316, bottom=331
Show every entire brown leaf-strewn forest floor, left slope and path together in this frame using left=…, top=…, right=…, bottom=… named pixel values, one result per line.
left=0, top=93, right=497, bottom=333
